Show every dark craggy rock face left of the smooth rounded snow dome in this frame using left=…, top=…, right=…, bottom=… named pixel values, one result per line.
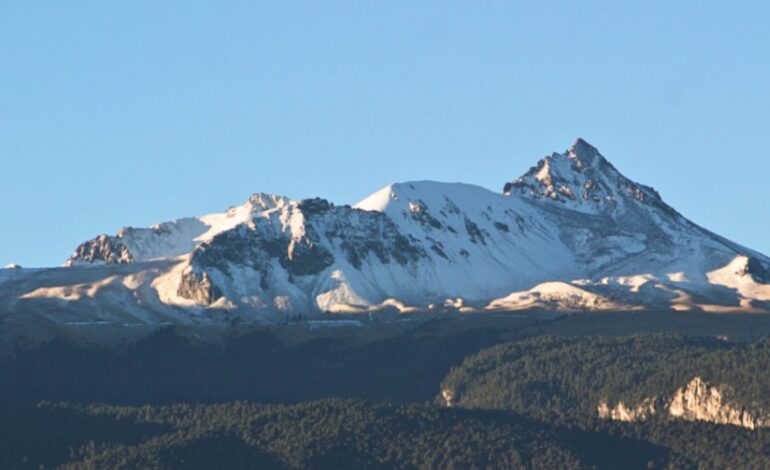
left=178, top=198, right=425, bottom=305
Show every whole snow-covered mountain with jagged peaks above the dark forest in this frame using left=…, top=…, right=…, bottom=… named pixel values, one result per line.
left=0, top=139, right=770, bottom=323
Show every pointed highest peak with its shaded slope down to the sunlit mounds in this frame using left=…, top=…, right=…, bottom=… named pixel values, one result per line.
left=503, top=139, right=703, bottom=275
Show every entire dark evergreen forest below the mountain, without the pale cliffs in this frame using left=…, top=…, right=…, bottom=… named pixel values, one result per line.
left=0, top=328, right=770, bottom=469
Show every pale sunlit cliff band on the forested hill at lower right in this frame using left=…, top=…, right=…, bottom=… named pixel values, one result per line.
left=597, top=377, right=770, bottom=429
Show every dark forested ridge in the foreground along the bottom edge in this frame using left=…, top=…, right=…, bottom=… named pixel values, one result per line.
left=0, top=400, right=693, bottom=469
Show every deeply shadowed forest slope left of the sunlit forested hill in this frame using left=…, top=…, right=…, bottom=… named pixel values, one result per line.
left=0, top=322, right=516, bottom=404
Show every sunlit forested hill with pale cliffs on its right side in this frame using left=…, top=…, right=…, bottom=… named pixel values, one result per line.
left=439, top=335, right=770, bottom=429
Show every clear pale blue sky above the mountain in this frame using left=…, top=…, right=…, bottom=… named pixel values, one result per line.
left=0, top=0, right=770, bottom=266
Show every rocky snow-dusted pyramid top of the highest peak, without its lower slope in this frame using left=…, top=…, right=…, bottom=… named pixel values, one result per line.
left=503, top=139, right=663, bottom=212
